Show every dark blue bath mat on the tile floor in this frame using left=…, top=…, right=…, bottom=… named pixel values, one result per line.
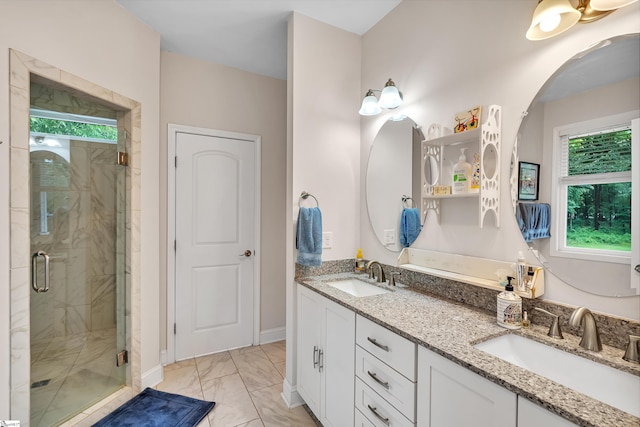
left=93, top=388, right=215, bottom=427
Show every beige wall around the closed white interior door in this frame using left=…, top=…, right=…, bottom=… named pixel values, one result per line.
left=159, top=51, right=287, bottom=348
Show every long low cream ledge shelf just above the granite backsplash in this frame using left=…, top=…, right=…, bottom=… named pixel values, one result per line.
left=398, top=248, right=544, bottom=298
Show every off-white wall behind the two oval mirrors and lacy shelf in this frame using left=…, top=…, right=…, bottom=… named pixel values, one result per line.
left=360, top=0, right=640, bottom=319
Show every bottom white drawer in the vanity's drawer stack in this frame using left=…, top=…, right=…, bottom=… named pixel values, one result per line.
left=356, top=378, right=415, bottom=427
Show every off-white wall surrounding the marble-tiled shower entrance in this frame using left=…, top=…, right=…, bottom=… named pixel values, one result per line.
left=0, top=0, right=160, bottom=419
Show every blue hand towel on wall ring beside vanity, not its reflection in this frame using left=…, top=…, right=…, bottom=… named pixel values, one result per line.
left=296, top=207, right=322, bottom=267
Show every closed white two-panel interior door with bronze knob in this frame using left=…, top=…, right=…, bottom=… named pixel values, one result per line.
left=174, top=132, right=256, bottom=360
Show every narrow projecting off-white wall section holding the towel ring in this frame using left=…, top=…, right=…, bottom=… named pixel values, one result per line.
left=283, top=13, right=361, bottom=405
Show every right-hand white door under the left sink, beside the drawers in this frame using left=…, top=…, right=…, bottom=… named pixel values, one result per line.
left=321, top=298, right=356, bottom=427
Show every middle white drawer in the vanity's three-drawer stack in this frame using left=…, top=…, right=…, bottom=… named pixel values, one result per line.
left=356, top=346, right=416, bottom=422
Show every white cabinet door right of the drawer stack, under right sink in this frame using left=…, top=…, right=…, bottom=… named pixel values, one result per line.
left=417, top=347, right=517, bottom=427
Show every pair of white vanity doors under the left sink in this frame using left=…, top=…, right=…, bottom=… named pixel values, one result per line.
left=297, top=285, right=355, bottom=427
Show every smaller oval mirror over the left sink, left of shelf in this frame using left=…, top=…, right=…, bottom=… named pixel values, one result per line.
left=365, top=117, right=422, bottom=252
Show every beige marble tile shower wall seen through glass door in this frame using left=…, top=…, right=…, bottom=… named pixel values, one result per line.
left=31, top=140, right=117, bottom=341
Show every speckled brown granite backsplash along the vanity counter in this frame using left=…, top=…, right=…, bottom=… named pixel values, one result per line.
left=295, top=259, right=640, bottom=350
